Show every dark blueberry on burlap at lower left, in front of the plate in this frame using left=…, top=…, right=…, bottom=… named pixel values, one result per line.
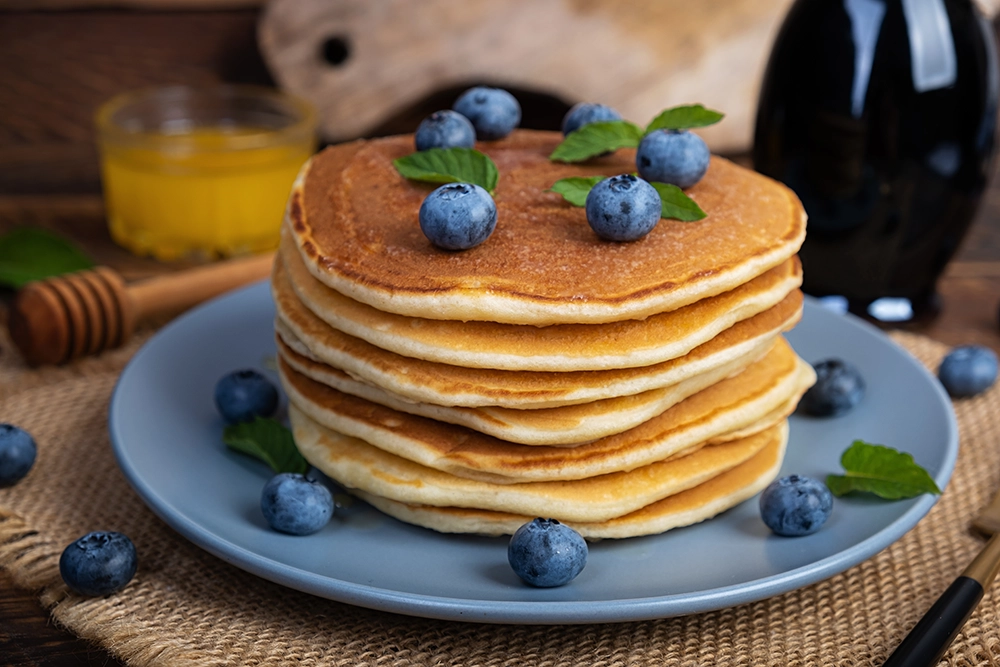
left=59, top=531, right=138, bottom=596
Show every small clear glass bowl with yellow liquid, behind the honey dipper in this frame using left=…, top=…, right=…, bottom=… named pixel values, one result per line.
left=96, top=86, right=316, bottom=260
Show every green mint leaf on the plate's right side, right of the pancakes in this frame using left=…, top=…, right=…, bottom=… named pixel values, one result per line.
left=826, top=440, right=941, bottom=500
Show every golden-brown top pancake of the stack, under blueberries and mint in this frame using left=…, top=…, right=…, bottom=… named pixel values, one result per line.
left=288, top=130, right=805, bottom=325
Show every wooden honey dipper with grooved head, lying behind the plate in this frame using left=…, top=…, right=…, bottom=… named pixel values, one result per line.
left=9, top=253, right=274, bottom=366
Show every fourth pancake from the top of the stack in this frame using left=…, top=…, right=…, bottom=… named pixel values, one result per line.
left=277, top=338, right=768, bottom=445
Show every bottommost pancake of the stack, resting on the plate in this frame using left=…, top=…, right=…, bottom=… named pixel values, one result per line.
left=353, top=430, right=786, bottom=540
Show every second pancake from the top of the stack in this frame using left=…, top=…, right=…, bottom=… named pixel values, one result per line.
left=280, top=232, right=802, bottom=371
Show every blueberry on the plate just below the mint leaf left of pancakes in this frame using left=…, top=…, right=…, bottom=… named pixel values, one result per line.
left=260, top=472, right=333, bottom=535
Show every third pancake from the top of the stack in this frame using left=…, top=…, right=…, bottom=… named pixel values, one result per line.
left=272, top=262, right=802, bottom=409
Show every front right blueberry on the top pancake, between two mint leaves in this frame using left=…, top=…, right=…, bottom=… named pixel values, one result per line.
left=586, top=174, right=662, bottom=241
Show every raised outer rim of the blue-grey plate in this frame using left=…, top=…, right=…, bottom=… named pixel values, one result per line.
left=108, top=279, right=958, bottom=625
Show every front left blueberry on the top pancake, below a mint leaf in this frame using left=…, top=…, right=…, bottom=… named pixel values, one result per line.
left=420, top=183, right=497, bottom=250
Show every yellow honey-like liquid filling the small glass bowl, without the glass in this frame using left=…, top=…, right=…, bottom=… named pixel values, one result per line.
left=102, top=128, right=313, bottom=260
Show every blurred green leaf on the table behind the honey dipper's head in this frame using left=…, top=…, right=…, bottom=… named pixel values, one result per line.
left=0, top=227, right=94, bottom=288
